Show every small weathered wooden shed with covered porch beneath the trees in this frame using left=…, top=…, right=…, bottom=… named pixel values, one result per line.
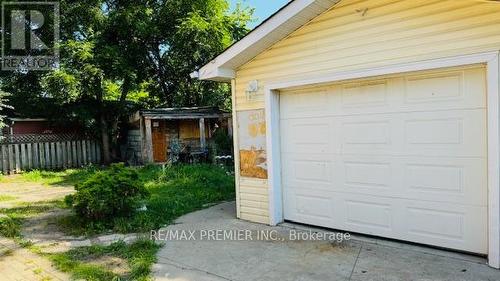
left=128, top=107, right=233, bottom=163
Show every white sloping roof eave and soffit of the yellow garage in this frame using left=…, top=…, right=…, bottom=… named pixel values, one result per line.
left=193, top=0, right=340, bottom=82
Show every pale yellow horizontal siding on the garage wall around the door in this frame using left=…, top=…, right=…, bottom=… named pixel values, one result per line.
left=233, top=0, right=500, bottom=223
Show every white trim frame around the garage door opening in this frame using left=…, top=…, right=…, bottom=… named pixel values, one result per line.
left=264, top=52, right=500, bottom=268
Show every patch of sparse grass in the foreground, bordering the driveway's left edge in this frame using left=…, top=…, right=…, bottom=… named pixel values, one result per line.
left=48, top=240, right=160, bottom=281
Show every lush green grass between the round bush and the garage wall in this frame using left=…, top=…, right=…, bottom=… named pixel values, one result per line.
left=60, top=164, right=235, bottom=235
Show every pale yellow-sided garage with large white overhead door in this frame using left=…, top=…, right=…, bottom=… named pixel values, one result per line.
left=195, top=0, right=500, bottom=268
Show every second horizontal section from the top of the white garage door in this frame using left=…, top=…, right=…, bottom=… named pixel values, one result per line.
left=280, top=109, right=487, bottom=157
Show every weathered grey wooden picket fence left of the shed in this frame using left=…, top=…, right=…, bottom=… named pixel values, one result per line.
left=0, top=140, right=101, bottom=174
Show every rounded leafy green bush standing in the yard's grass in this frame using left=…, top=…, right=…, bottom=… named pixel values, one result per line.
left=65, top=164, right=148, bottom=222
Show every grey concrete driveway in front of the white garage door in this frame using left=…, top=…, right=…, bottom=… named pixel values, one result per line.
left=153, top=203, right=500, bottom=281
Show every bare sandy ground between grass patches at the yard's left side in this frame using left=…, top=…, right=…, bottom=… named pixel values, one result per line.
left=0, top=176, right=145, bottom=281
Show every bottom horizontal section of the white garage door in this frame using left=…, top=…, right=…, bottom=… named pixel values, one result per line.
left=284, top=188, right=487, bottom=253
